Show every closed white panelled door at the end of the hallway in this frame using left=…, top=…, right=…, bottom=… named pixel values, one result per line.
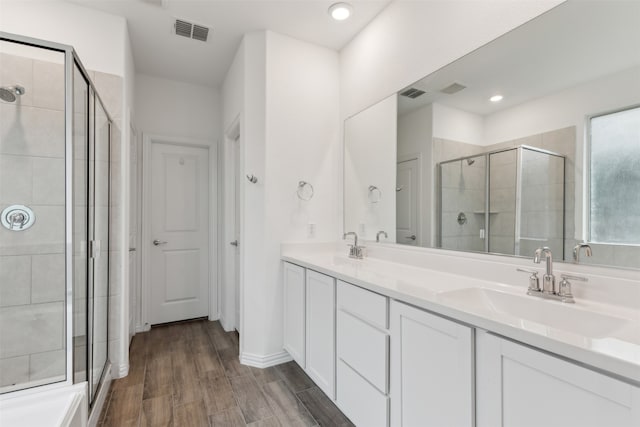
left=147, top=143, right=209, bottom=324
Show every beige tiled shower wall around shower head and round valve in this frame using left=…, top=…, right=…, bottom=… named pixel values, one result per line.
left=0, top=53, right=65, bottom=390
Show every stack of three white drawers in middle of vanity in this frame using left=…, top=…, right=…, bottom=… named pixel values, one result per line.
left=336, top=280, right=389, bottom=427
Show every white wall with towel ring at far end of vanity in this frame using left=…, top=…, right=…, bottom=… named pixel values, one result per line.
left=222, top=32, right=340, bottom=365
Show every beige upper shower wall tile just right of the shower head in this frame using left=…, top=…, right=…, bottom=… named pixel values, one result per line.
left=33, top=60, right=64, bottom=111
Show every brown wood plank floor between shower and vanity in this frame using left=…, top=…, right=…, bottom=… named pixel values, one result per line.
left=98, top=320, right=353, bottom=427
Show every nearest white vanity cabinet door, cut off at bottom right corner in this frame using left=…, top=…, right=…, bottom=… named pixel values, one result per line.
left=476, top=332, right=640, bottom=427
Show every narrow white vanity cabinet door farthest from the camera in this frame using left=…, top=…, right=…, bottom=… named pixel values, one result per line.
left=283, top=262, right=305, bottom=369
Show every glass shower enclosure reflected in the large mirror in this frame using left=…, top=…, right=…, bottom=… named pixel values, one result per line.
left=437, top=145, right=565, bottom=259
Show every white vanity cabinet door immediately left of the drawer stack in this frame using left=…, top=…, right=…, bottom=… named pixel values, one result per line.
left=306, top=270, right=336, bottom=400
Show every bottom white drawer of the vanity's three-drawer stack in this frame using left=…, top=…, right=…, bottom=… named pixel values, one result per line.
left=336, top=360, right=389, bottom=427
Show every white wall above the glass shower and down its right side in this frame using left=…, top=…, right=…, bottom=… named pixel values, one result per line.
left=0, top=0, right=135, bottom=377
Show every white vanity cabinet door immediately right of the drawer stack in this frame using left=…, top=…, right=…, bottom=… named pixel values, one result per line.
left=390, top=301, right=474, bottom=427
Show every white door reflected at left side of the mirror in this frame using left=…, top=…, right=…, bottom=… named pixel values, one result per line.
left=396, top=159, right=420, bottom=246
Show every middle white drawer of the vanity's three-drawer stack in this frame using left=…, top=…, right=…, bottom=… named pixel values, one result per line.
left=337, top=310, right=389, bottom=393
